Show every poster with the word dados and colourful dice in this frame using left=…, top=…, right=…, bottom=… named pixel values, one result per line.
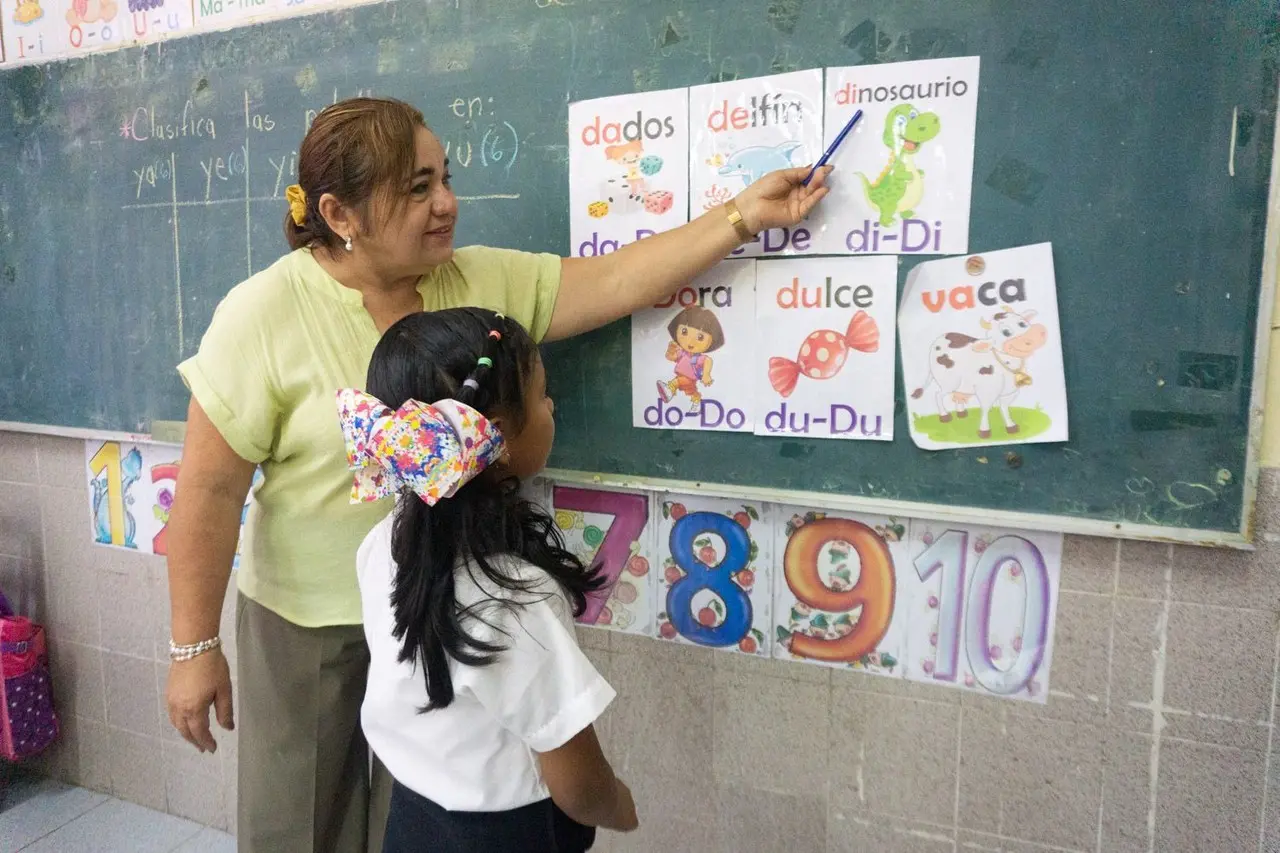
left=568, top=88, right=689, bottom=257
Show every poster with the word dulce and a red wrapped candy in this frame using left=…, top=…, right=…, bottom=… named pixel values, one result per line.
left=755, top=257, right=897, bottom=441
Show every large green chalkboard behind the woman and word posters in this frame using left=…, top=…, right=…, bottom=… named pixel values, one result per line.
left=0, top=0, right=1280, bottom=532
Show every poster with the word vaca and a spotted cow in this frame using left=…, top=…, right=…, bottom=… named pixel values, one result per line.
left=899, top=243, right=1068, bottom=450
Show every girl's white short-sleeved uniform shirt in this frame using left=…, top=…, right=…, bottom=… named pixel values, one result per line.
left=356, top=517, right=614, bottom=812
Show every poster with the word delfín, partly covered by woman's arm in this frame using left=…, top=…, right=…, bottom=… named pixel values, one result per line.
left=689, top=68, right=822, bottom=257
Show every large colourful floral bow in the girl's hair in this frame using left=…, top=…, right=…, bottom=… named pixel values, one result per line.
left=338, top=388, right=506, bottom=506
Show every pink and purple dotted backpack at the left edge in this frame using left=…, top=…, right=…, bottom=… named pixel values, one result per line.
left=0, top=593, right=58, bottom=761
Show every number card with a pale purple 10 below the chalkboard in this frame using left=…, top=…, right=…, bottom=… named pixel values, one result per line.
left=901, top=520, right=1062, bottom=703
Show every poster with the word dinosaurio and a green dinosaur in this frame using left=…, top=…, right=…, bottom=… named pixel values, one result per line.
left=812, top=56, right=978, bottom=255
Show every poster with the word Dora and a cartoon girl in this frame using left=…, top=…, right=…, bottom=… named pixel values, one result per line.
left=631, top=260, right=756, bottom=433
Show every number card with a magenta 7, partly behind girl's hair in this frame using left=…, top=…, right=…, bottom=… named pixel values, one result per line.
left=550, top=484, right=658, bottom=635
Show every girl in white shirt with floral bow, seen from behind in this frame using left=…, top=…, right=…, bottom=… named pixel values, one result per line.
left=338, top=309, right=636, bottom=853
